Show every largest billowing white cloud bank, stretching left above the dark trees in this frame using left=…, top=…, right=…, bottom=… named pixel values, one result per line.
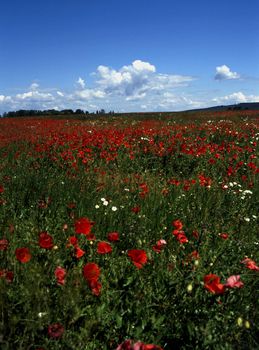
left=0, top=60, right=197, bottom=111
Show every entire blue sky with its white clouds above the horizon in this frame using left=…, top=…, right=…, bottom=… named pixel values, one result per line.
left=0, top=0, right=259, bottom=113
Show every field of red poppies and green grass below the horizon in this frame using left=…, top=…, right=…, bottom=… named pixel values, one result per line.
left=0, top=111, right=259, bottom=350
